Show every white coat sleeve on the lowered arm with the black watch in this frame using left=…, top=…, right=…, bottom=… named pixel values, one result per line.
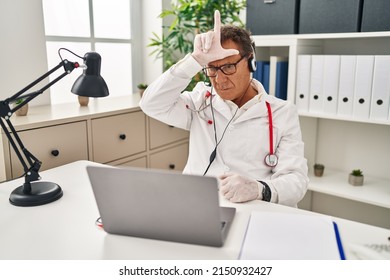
left=264, top=103, right=309, bottom=207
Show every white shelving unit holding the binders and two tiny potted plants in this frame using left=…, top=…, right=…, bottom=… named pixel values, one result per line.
left=253, top=32, right=390, bottom=228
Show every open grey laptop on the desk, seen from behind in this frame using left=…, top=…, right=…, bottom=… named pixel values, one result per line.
left=87, top=166, right=236, bottom=247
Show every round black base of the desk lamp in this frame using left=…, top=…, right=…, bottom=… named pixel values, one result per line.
left=9, top=182, right=63, bottom=206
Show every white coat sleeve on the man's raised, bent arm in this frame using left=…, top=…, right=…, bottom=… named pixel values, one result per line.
left=139, top=54, right=202, bottom=130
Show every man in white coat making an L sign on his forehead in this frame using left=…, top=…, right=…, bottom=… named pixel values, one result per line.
left=140, top=11, right=308, bottom=207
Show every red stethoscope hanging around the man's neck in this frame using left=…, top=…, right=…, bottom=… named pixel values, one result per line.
left=186, top=91, right=278, bottom=167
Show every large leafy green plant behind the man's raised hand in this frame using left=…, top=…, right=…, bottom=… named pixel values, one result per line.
left=148, top=0, right=246, bottom=90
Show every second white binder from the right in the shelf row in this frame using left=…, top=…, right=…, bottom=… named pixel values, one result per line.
left=352, top=55, right=374, bottom=119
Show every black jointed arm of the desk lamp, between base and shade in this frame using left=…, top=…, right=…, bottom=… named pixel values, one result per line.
left=0, top=60, right=79, bottom=186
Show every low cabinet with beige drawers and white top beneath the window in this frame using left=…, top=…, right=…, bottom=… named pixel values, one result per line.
left=0, top=94, right=188, bottom=180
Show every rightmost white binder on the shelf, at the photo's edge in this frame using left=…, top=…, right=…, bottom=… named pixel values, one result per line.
left=370, top=55, right=390, bottom=120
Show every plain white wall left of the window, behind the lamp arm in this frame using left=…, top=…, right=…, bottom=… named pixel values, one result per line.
left=0, top=0, right=50, bottom=106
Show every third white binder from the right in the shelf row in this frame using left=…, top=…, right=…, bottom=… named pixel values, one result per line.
left=337, top=55, right=356, bottom=116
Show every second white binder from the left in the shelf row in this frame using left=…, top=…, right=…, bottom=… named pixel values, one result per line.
left=309, top=55, right=324, bottom=113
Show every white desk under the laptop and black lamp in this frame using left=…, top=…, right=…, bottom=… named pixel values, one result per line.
left=0, top=161, right=390, bottom=260
